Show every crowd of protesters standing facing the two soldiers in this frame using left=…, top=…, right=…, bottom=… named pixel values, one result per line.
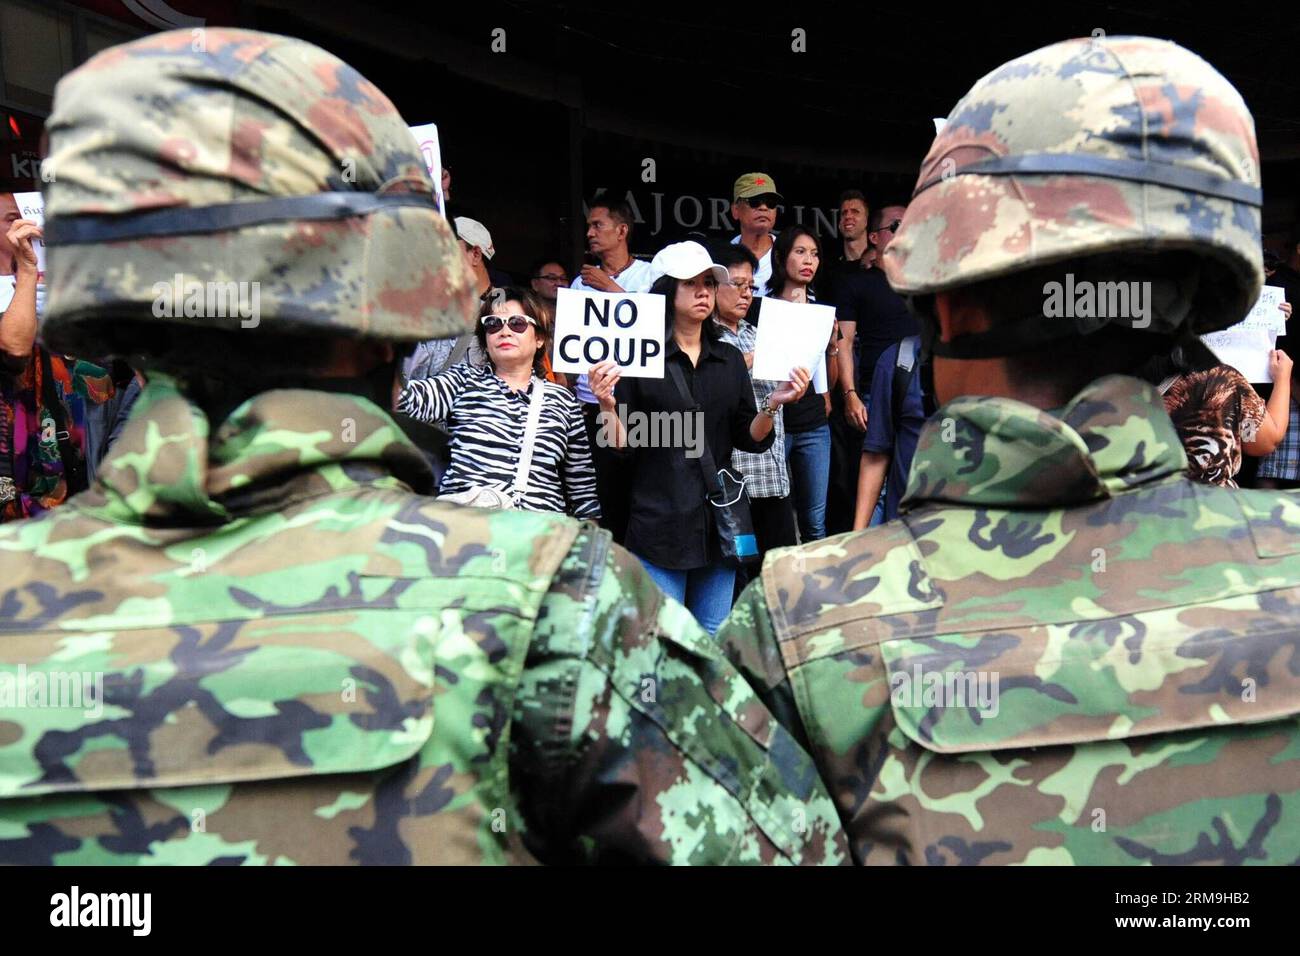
left=0, top=172, right=1300, bottom=631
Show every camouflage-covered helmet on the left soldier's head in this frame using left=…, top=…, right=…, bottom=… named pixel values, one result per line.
left=43, top=29, right=473, bottom=355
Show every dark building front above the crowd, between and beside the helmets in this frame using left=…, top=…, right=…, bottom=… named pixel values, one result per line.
left=0, top=0, right=1300, bottom=276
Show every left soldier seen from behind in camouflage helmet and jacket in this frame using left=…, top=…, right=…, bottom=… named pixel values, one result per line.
left=0, top=30, right=846, bottom=864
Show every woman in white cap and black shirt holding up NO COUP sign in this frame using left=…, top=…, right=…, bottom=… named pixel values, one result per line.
left=589, top=242, right=809, bottom=633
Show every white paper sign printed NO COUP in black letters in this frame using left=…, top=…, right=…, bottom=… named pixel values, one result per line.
left=551, top=289, right=664, bottom=378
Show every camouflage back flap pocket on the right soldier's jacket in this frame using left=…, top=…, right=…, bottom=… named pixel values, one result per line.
left=880, top=608, right=1300, bottom=753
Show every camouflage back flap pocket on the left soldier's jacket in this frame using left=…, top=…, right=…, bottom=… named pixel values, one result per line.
left=0, top=610, right=433, bottom=797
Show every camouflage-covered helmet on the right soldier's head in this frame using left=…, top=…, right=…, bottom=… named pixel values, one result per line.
left=883, top=36, right=1264, bottom=358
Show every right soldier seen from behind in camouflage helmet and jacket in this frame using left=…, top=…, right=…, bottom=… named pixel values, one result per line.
left=719, top=38, right=1300, bottom=864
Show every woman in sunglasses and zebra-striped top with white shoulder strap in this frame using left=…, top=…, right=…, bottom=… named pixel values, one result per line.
left=397, top=289, right=601, bottom=519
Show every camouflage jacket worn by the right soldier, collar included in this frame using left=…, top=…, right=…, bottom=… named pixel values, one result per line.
left=719, top=376, right=1300, bottom=864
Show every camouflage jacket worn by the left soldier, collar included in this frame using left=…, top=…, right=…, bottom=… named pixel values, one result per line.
left=0, top=380, right=848, bottom=864
